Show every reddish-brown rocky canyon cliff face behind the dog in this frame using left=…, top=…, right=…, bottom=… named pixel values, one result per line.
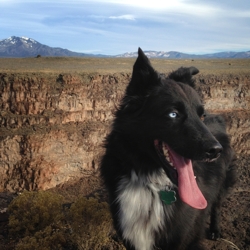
left=0, top=73, right=250, bottom=191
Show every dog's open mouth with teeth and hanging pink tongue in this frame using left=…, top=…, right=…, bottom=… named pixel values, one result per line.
left=154, top=140, right=207, bottom=209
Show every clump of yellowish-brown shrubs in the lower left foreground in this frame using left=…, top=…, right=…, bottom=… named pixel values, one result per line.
left=8, top=191, right=124, bottom=250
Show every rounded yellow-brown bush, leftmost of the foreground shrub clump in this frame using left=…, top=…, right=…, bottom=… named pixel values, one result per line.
left=8, top=191, right=63, bottom=237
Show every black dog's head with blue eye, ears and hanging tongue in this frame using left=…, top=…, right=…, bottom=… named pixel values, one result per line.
left=115, top=48, right=222, bottom=208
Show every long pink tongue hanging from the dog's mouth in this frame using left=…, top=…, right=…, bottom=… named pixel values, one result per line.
left=168, top=148, right=207, bottom=209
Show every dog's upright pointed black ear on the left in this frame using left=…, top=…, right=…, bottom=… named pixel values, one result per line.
left=127, top=48, right=159, bottom=96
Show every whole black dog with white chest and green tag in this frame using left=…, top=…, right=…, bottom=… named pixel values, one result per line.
left=101, top=48, right=235, bottom=250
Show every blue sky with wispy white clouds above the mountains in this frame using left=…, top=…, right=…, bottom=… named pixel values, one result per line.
left=0, top=0, right=250, bottom=55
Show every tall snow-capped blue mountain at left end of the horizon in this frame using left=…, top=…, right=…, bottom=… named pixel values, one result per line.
left=0, top=36, right=106, bottom=57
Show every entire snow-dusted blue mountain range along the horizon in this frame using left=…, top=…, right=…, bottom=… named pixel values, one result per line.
left=0, top=36, right=250, bottom=59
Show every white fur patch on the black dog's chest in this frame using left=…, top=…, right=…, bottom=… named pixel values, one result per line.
left=117, top=170, right=173, bottom=250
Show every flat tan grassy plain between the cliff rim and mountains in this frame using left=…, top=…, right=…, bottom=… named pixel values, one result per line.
left=0, top=57, right=250, bottom=74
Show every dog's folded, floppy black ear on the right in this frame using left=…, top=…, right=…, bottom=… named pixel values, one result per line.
left=168, top=67, right=199, bottom=88
